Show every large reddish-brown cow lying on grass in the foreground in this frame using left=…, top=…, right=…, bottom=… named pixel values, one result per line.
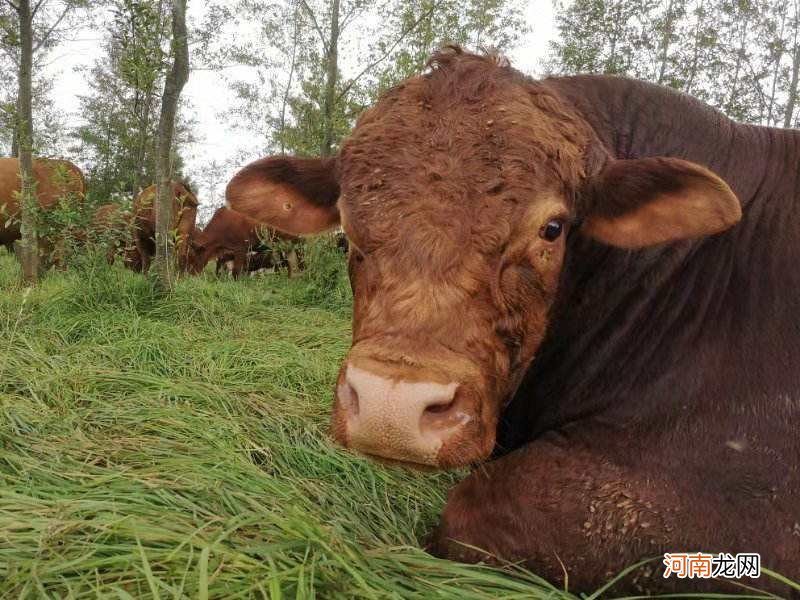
left=227, top=50, right=800, bottom=595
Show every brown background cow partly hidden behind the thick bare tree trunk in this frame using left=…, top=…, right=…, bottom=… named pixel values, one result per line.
left=133, top=182, right=198, bottom=273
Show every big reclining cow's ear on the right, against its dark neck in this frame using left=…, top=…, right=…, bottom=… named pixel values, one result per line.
left=578, top=158, right=742, bottom=248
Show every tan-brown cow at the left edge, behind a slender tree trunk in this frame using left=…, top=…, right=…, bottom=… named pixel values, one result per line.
left=0, top=158, right=86, bottom=252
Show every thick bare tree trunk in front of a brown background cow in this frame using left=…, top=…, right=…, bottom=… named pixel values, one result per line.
left=155, top=0, right=189, bottom=291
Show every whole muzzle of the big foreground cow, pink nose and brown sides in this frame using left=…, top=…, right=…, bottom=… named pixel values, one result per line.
left=333, top=362, right=494, bottom=468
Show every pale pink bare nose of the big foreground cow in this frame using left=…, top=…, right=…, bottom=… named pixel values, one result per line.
left=336, top=364, right=473, bottom=465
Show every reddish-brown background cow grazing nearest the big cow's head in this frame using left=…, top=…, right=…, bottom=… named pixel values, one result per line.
left=190, top=206, right=297, bottom=277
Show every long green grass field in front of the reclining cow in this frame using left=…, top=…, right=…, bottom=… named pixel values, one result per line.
left=0, top=247, right=792, bottom=599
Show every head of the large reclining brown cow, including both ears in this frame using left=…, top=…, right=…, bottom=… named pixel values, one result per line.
left=227, top=51, right=741, bottom=468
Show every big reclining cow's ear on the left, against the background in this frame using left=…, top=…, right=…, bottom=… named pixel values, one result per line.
left=225, top=156, right=339, bottom=235
